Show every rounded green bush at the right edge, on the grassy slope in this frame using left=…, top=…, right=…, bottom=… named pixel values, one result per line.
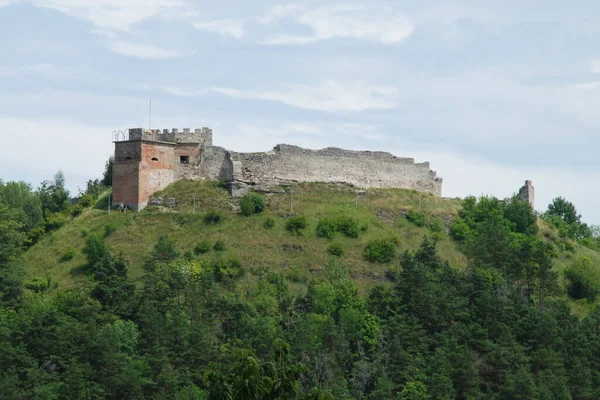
left=565, top=257, right=600, bottom=302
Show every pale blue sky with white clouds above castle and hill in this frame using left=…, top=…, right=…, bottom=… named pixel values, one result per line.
left=0, top=0, right=600, bottom=224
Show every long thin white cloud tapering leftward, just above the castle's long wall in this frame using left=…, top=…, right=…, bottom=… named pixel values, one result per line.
left=213, top=81, right=398, bottom=111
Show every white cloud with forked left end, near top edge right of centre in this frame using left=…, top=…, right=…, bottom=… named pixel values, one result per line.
left=258, top=5, right=414, bottom=45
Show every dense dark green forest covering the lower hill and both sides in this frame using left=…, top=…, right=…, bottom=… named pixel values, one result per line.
left=0, top=167, right=600, bottom=400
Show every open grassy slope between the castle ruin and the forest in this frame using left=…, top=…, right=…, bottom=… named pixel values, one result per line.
left=21, top=181, right=466, bottom=288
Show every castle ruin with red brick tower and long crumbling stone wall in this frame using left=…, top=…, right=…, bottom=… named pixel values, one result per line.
left=113, top=128, right=442, bottom=210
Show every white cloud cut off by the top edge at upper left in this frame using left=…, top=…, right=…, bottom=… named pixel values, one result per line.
left=28, top=0, right=184, bottom=31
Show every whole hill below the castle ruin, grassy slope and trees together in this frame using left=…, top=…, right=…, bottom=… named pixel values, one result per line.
left=7, top=181, right=600, bottom=400
